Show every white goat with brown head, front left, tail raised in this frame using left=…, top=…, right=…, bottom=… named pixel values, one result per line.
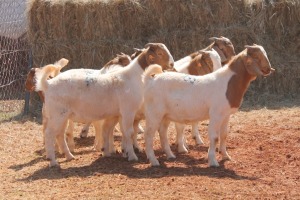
left=36, top=43, right=174, bottom=166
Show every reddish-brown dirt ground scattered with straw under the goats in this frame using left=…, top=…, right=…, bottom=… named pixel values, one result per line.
left=0, top=101, right=300, bottom=199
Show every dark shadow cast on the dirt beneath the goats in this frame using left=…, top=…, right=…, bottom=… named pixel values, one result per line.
left=10, top=137, right=257, bottom=182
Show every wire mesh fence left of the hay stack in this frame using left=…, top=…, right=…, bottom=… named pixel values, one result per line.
left=0, top=0, right=30, bottom=121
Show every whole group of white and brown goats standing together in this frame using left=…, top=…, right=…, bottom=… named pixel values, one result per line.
left=25, top=37, right=274, bottom=166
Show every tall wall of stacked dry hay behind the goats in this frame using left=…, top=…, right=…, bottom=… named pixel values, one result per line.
left=27, top=0, right=300, bottom=115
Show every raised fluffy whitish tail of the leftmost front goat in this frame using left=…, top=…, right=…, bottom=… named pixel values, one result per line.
left=35, top=58, right=69, bottom=92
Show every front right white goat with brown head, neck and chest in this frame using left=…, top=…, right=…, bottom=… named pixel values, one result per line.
left=144, top=45, right=274, bottom=166
